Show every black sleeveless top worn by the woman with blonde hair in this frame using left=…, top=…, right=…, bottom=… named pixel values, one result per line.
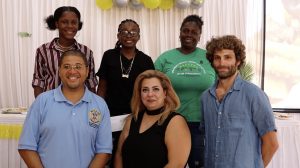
left=122, top=112, right=180, bottom=168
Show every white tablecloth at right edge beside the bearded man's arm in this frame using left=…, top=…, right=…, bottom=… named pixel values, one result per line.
left=267, top=119, right=300, bottom=168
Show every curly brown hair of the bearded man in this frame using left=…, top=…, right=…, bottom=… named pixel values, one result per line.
left=206, top=35, right=246, bottom=69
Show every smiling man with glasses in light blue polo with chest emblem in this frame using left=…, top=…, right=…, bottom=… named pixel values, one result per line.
left=19, top=51, right=112, bottom=168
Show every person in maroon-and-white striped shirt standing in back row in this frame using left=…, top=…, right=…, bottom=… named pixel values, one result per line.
left=32, top=6, right=98, bottom=97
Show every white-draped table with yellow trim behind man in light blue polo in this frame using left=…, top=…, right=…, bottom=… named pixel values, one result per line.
left=0, top=114, right=127, bottom=168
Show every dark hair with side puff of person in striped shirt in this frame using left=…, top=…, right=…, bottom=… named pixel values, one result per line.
left=45, top=6, right=83, bottom=30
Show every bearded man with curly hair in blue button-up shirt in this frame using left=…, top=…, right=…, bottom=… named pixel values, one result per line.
left=201, top=36, right=278, bottom=168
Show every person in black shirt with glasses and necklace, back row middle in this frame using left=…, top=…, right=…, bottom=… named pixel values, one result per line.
left=96, top=19, right=154, bottom=167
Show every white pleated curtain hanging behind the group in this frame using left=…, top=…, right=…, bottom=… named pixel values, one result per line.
left=0, top=0, right=263, bottom=108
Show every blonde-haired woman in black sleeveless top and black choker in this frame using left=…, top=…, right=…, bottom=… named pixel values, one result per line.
left=115, top=70, right=191, bottom=168
